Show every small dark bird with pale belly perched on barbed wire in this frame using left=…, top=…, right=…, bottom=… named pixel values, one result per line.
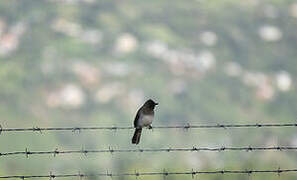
left=132, top=99, right=158, bottom=145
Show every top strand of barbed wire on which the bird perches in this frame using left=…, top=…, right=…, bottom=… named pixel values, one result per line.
left=0, top=123, right=297, bottom=134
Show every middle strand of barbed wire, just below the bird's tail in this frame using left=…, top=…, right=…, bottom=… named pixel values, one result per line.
left=0, top=146, right=297, bottom=158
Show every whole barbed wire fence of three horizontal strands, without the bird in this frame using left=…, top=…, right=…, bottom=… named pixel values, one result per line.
left=0, top=123, right=297, bottom=179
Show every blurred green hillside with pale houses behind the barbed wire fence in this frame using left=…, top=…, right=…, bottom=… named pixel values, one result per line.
left=0, top=0, right=297, bottom=180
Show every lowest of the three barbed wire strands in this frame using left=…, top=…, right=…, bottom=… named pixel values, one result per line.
left=0, top=168, right=297, bottom=179
